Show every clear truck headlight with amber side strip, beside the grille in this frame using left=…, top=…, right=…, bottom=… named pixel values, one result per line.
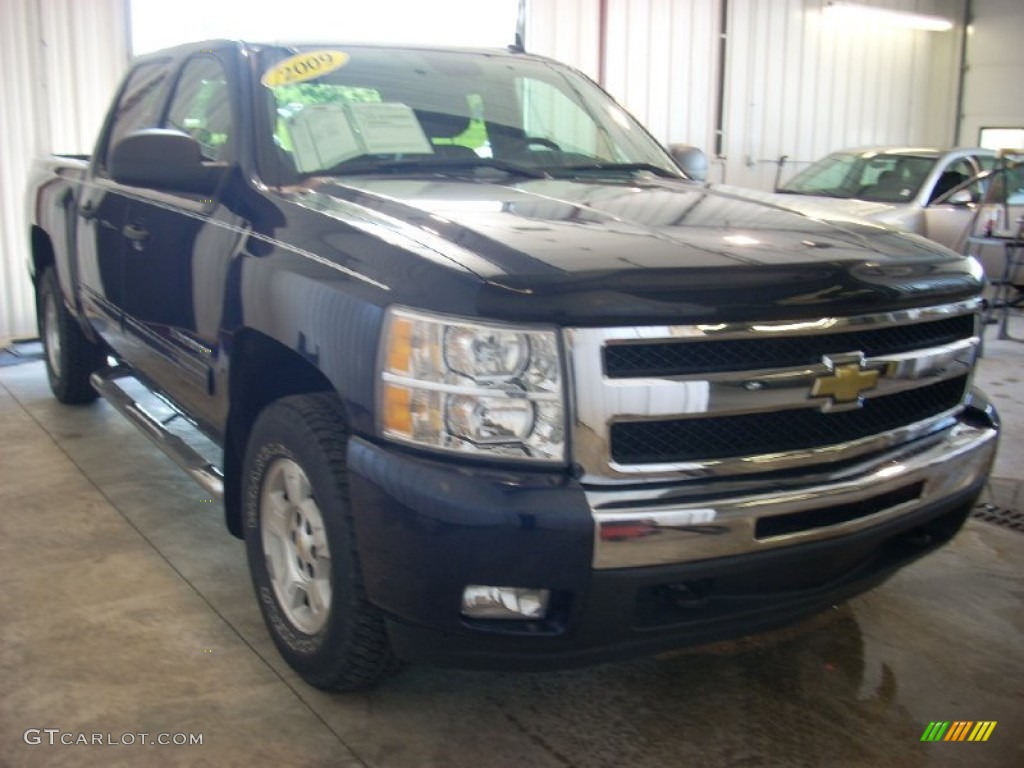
left=378, top=308, right=565, bottom=462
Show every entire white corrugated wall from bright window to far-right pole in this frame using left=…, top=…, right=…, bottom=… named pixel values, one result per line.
left=526, top=0, right=967, bottom=189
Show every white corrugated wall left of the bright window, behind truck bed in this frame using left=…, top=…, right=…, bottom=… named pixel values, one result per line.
left=0, top=0, right=128, bottom=343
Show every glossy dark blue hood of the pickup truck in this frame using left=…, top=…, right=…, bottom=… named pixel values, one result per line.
left=292, top=177, right=981, bottom=325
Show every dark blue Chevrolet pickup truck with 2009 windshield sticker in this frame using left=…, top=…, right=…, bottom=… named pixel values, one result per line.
left=29, top=41, right=998, bottom=689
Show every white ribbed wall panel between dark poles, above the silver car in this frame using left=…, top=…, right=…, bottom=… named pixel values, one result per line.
left=725, top=0, right=965, bottom=189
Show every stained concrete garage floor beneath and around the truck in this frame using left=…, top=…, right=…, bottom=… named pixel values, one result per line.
left=0, top=319, right=1024, bottom=768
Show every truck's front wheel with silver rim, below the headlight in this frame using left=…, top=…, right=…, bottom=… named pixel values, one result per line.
left=242, top=393, right=398, bottom=691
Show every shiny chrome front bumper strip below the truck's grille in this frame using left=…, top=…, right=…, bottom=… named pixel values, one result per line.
left=587, top=421, right=998, bottom=569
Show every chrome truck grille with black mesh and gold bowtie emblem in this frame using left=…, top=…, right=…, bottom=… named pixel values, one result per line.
left=565, top=301, right=979, bottom=484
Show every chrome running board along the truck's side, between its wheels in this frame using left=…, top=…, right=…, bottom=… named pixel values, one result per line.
left=89, top=367, right=224, bottom=499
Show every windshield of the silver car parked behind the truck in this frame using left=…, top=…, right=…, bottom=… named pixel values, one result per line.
left=778, top=153, right=935, bottom=203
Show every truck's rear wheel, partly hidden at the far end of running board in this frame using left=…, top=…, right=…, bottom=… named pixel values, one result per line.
left=37, top=266, right=105, bottom=404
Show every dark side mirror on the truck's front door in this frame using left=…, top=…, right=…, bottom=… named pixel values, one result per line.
left=108, top=128, right=228, bottom=195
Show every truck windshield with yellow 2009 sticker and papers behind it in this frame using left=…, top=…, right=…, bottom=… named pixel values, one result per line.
left=259, top=46, right=682, bottom=178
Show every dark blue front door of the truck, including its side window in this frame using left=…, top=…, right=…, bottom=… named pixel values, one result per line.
left=122, top=54, right=242, bottom=428
